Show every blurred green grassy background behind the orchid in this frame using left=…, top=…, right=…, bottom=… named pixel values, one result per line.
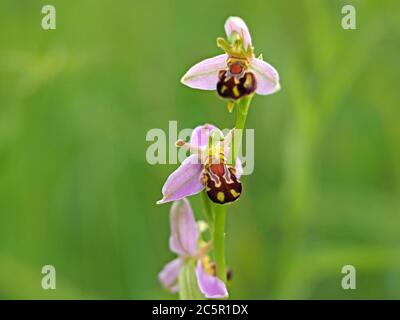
left=0, top=0, right=400, bottom=299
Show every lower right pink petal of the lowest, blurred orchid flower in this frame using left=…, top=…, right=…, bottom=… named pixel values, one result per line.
left=196, top=260, right=228, bottom=299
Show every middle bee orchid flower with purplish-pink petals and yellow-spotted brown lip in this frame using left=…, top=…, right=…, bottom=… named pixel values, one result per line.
left=157, top=124, right=242, bottom=204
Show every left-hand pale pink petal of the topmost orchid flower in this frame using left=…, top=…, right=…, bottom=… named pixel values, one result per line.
left=181, top=54, right=228, bottom=90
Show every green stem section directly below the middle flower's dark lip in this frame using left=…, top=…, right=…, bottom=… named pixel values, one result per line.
left=214, top=204, right=226, bottom=283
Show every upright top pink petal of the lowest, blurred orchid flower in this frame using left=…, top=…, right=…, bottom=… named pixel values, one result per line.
left=169, top=198, right=199, bottom=257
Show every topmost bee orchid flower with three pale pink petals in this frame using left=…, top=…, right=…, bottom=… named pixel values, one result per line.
left=181, top=17, right=280, bottom=101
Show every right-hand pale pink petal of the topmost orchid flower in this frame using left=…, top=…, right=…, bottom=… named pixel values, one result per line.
left=250, top=58, right=280, bottom=95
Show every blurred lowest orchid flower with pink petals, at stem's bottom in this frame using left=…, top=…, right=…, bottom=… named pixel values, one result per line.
left=158, top=198, right=228, bottom=298
